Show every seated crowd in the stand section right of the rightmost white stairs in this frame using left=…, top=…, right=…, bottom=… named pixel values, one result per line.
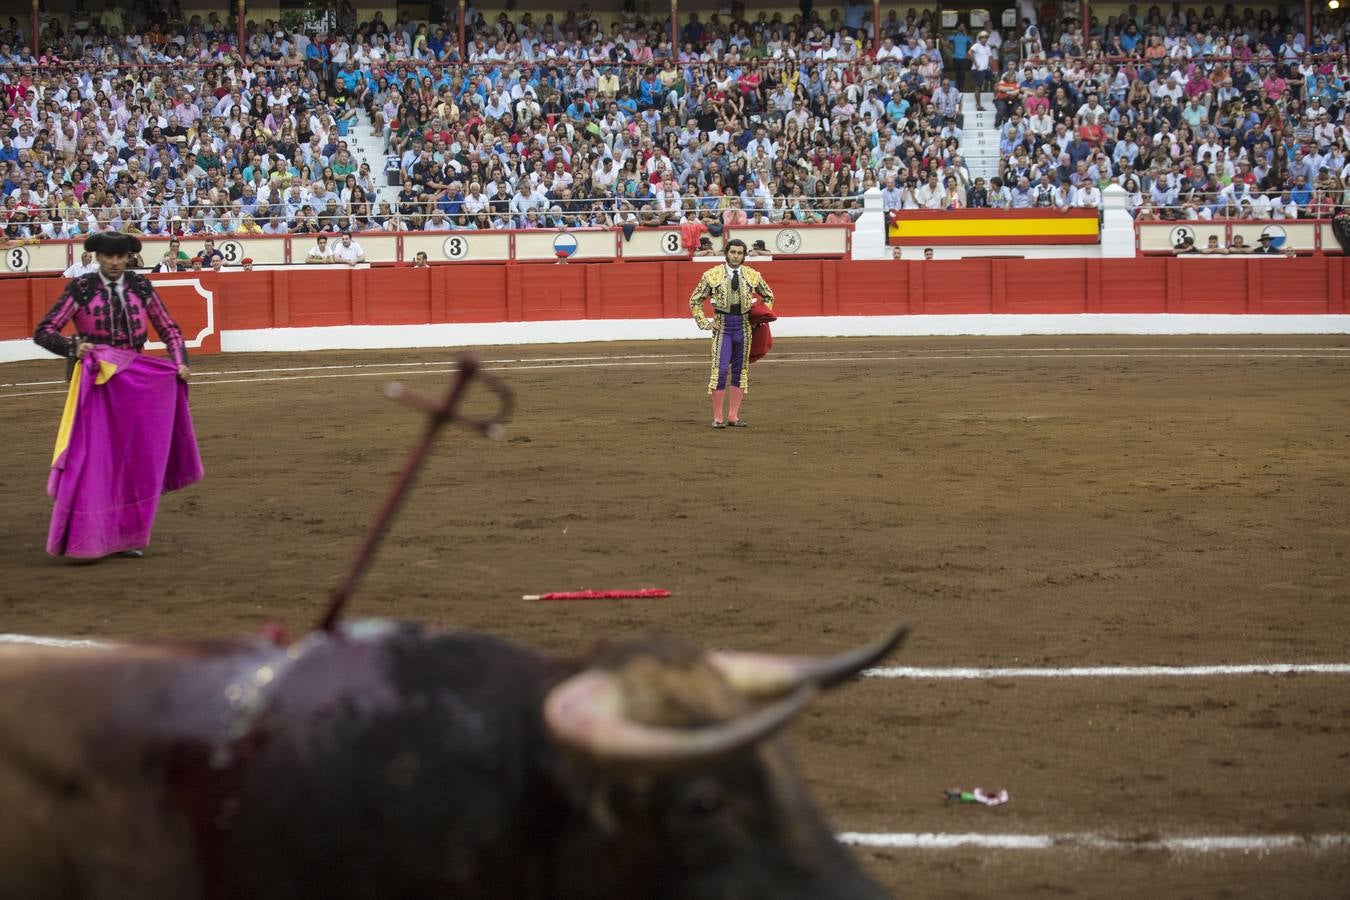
left=886, top=4, right=1350, bottom=220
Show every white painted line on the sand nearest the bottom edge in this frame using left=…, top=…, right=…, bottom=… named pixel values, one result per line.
left=838, top=831, right=1350, bottom=853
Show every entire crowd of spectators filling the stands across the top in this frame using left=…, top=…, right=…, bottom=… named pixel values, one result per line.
left=0, top=0, right=1350, bottom=248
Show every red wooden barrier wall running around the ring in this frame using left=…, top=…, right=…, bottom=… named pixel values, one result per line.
left=0, top=256, right=1350, bottom=352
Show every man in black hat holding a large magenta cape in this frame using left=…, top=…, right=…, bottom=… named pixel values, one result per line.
left=34, top=232, right=203, bottom=560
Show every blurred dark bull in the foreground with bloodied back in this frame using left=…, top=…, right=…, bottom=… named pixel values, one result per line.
left=0, top=622, right=903, bottom=900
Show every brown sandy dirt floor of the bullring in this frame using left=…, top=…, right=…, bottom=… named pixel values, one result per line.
left=0, top=337, right=1350, bottom=897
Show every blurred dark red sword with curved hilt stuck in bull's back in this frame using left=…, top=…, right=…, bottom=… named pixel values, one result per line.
left=319, top=354, right=514, bottom=631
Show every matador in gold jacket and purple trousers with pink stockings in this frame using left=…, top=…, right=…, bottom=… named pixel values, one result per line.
left=689, top=239, right=774, bottom=428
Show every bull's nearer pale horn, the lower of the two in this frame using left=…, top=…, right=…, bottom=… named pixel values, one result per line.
left=544, top=669, right=817, bottom=769
